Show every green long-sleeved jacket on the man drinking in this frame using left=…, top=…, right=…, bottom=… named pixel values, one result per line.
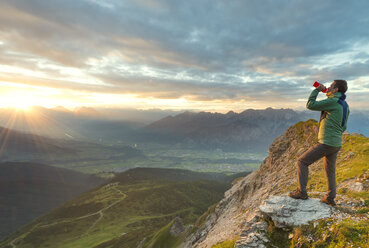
left=306, top=89, right=350, bottom=147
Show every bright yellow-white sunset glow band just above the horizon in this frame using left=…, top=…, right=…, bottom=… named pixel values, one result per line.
left=0, top=82, right=290, bottom=113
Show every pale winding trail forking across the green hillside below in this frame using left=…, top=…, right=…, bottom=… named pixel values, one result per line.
left=9, top=185, right=127, bottom=248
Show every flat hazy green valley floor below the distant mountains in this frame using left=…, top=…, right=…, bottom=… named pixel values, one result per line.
left=0, top=130, right=265, bottom=174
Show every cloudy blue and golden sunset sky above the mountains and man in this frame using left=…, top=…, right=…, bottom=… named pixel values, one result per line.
left=0, top=0, right=369, bottom=113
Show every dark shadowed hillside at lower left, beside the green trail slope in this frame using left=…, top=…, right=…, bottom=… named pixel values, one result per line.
left=0, top=162, right=105, bottom=239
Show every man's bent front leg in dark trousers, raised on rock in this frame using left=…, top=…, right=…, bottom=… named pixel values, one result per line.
left=297, top=143, right=327, bottom=194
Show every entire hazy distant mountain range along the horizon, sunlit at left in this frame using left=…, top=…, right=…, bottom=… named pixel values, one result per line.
left=0, top=107, right=369, bottom=153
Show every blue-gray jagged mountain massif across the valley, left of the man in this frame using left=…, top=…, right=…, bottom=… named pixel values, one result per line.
left=132, top=108, right=308, bottom=152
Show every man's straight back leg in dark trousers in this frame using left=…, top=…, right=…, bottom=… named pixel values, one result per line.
left=323, top=147, right=341, bottom=200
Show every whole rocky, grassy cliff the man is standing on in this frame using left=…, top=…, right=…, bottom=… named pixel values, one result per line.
left=181, top=120, right=369, bottom=248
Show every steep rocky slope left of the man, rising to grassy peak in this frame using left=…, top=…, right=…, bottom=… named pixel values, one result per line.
left=181, top=120, right=318, bottom=248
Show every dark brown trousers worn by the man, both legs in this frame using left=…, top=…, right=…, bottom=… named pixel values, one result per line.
left=297, top=143, right=341, bottom=199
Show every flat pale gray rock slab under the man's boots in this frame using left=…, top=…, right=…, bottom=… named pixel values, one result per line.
left=259, top=196, right=333, bottom=228
